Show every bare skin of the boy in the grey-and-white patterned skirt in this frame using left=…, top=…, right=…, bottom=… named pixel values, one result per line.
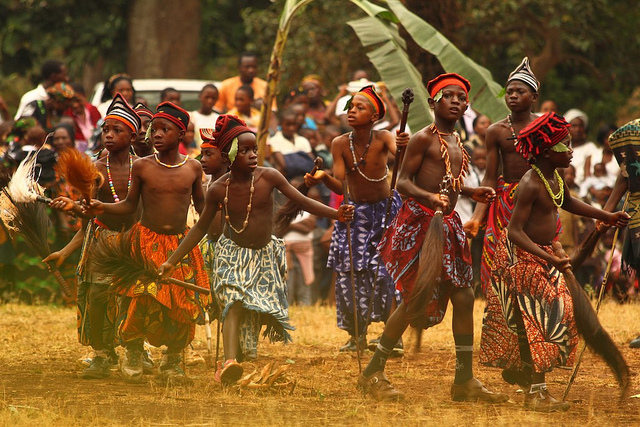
left=158, top=132, right=353, bottom=360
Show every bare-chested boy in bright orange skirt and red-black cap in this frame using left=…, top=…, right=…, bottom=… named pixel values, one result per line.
left=91, top=102, right=209, bottom=383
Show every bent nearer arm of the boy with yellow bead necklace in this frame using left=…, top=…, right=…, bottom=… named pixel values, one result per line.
left=507, top=180, right=571, bottom=271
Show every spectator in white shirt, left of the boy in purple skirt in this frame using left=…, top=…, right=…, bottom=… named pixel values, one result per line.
left=267, top=110, right=313, bottom=180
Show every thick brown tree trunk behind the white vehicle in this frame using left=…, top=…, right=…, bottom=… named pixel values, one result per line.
left=127, top=0, right=200, bottom=78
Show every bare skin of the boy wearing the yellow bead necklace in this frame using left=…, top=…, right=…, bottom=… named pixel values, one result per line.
left=507, top=136, right=629, bottom=384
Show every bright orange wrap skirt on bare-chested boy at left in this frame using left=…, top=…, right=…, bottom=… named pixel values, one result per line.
left=117, top=223, right=211, bottom=348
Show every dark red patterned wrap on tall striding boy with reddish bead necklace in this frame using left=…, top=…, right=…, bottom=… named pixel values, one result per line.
left=378, top=198, right=473, bottom=329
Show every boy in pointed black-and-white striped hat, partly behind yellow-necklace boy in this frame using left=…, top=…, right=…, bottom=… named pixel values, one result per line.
left=464, top=57, right=540, bottom=296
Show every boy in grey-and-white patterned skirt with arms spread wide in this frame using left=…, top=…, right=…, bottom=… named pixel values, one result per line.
left=159, top=114, right=353, bottom=384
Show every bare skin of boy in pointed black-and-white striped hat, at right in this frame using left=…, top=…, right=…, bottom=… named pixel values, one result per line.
left=464, top=80, right=538, bottom=237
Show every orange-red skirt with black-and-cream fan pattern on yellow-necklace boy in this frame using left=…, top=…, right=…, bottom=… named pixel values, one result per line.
left=480, top=233, right=578, bottom=372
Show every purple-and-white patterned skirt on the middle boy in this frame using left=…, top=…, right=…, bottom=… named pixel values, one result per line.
left=327, top=191, right=402, bottom=336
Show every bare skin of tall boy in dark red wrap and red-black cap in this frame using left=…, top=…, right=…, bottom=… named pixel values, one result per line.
left=364, top=85, right=495, bottom=384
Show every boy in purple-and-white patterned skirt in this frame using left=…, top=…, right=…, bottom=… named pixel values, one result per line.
left=305, top=86, right=409, bottom=351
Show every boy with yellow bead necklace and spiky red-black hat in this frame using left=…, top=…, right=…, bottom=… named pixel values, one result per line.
left=480, top=112, right=629, bottom=412
